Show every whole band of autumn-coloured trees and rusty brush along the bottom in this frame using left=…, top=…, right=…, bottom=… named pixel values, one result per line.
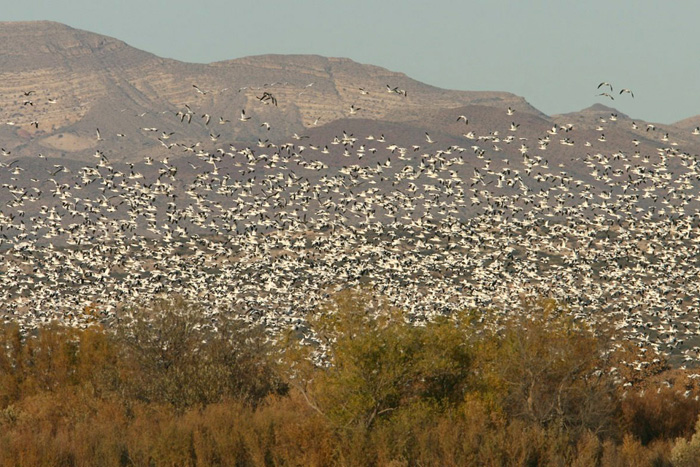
left=0, top=291, right=700, bottom=466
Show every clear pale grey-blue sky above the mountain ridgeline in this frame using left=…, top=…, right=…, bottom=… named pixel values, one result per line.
left=0, top=0, right=700, bottom=123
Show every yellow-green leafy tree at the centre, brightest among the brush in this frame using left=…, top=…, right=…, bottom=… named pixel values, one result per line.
left=288, top=290, right=472, bottom=428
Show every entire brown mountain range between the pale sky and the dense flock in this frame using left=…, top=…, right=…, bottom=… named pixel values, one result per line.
left=0, top=21, right=700, bottom=176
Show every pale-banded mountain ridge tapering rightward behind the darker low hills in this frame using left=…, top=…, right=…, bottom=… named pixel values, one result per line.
left=0, top=21, right=541, bottom=161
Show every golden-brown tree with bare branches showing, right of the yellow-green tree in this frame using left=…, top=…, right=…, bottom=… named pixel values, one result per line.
left=479, top=301, right=619, bottom=442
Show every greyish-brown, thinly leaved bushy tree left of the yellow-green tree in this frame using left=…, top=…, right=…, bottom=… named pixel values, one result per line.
left=117, top=298, right=286, bottom=409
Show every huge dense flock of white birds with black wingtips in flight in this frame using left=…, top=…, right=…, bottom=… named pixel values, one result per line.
left=0, top=77, right=700, bottom=366
